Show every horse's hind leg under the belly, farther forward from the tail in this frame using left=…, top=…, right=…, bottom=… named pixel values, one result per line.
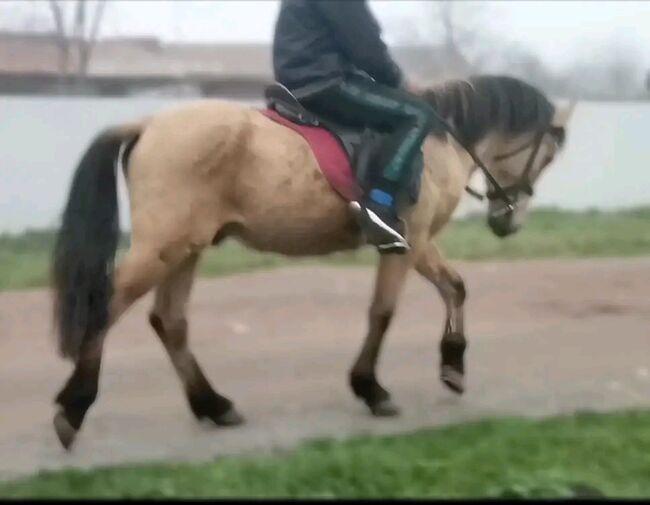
left=149, top=254, right=243, bottom=426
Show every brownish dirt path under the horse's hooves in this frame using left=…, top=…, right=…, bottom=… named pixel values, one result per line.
left=0, top=259, right=650, bottom=478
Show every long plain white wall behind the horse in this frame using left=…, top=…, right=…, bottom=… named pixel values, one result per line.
left=0, top=97, right=650, bottom=232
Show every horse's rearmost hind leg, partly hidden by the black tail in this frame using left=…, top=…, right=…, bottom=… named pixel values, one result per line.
left=54, top=242, right=182, bottom=449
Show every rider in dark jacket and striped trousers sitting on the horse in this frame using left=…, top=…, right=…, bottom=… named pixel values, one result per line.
left=273, top=0, right=433, bottom=253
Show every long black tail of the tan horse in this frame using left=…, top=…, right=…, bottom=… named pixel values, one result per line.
left=52, top=130, right=137, bottom=359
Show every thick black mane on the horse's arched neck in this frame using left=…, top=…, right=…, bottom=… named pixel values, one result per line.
left=423, top=75, right=555, bottom=145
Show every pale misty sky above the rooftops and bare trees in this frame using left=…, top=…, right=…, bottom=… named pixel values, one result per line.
left=5, top=0, right=650, bottom=72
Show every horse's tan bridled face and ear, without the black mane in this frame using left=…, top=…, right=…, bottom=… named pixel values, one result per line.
left=486, top=102, right=575, bottom=237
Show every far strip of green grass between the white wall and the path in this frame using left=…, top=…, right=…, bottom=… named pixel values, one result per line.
left=0, top=207, right=650, bottom=290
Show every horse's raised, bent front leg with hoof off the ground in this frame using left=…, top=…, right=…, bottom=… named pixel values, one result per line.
left=415, top=243, right=467, bottom=394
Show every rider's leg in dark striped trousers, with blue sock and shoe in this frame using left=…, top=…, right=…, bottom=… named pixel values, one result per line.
left=302, top=79, right=433, bottom=252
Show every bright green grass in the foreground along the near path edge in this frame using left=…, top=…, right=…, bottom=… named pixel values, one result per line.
left=0, top=411, right=650, bottom=498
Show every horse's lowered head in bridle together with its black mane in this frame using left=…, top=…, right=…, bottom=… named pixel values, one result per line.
left=423, top=75, right=575, bottom=237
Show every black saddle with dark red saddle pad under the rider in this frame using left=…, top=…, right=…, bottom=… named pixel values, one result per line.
left=262, top=83, right=424, bottom=204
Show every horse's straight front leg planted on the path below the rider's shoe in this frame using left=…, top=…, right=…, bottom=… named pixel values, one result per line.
left=350, top=255, right=412, bottom=416
